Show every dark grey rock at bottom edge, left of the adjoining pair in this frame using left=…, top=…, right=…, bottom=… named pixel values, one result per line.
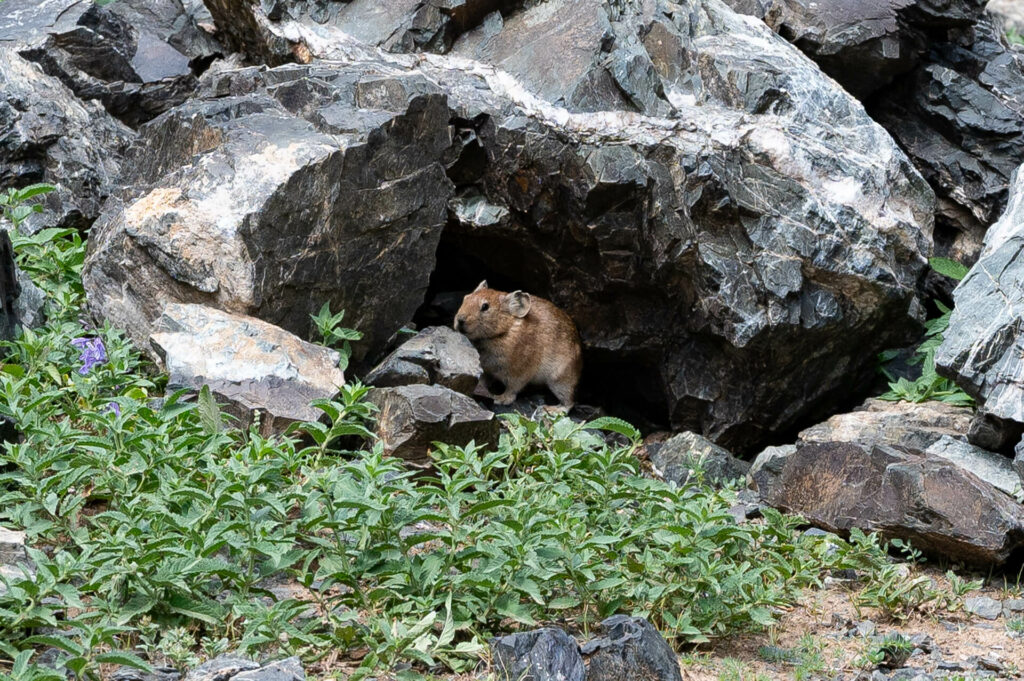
left=490, top=628, right=589, bottom=681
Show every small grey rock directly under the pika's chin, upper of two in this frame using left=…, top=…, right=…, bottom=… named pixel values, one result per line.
left=364, top=327, right=483, bottom=395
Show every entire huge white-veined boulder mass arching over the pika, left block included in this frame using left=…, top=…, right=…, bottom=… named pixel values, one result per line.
left=85, top=0, right=933, bottom=453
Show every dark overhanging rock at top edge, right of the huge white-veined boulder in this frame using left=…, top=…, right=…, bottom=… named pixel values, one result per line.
left=726, top=0, right=985, bottom=98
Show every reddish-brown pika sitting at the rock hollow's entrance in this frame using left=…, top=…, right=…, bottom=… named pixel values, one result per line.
left=455, top=281, right=583, bottom=410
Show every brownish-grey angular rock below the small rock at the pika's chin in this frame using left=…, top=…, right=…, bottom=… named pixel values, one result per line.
left=368, top=385, right=499, bottom=465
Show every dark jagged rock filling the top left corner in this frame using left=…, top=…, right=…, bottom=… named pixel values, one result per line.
left=0, top=0, right=216, bottom=126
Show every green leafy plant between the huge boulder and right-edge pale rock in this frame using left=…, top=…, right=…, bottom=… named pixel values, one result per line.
left=879, top=258, right=974, bottom=407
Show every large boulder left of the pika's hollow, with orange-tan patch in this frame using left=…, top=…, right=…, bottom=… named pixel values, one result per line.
left=83, top=67, right=451, bottom=360
